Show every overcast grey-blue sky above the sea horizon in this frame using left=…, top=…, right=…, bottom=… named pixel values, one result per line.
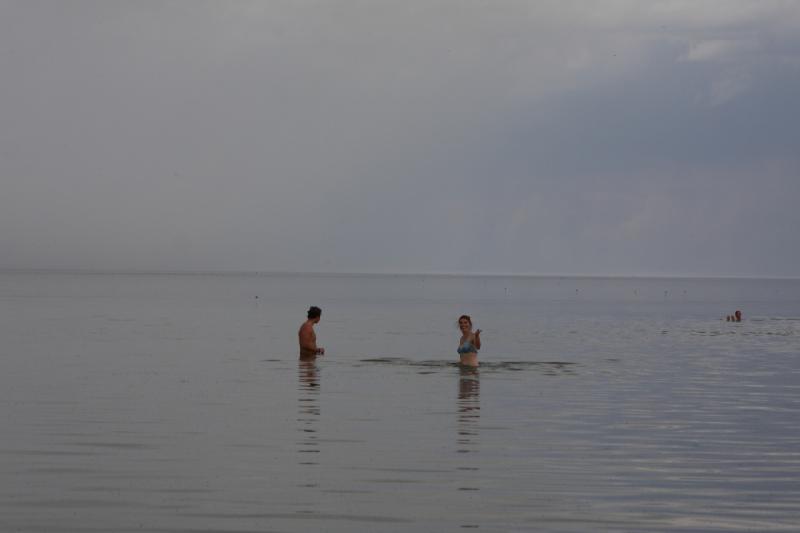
left=0, top=0, right=800, bottom=276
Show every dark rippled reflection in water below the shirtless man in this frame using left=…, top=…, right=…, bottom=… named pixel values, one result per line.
left=297, top=358, right=320, bottom=465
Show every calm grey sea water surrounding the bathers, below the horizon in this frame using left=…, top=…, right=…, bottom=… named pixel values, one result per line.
left=0, top=273, right=800, bottom=533
